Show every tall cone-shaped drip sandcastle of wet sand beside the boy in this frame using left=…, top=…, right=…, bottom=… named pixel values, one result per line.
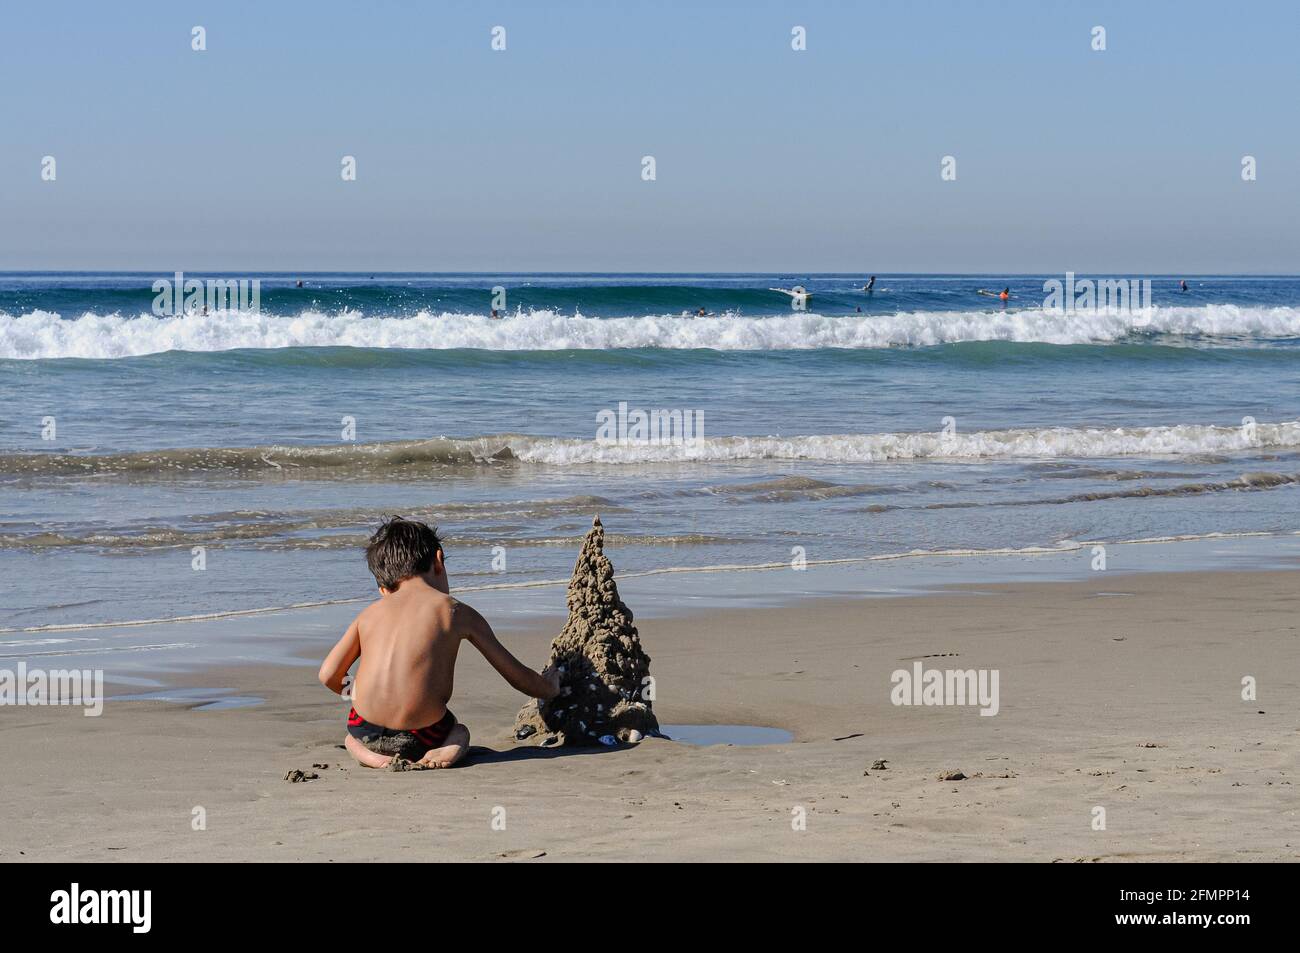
left=515, top=516, right=659, bottom=745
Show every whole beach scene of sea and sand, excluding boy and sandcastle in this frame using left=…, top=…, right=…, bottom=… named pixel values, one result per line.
left=0, top=273, right=1300, bottom=862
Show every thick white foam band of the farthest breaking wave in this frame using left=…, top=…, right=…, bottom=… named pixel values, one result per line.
left=0, top=304, right=1300, bottom=360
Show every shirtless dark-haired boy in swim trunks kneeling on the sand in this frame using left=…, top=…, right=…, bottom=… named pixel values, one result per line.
left=320, top=516, right=560, bottom=767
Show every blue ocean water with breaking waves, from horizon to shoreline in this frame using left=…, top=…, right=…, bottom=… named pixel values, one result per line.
left=0, top=273, right=1300, bottom=647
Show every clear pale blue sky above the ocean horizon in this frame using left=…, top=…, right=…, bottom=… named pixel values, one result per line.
left=0, top=0, right=1300, bottom=273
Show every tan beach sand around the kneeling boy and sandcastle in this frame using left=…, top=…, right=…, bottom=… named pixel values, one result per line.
left=0, top=572, right=1300, bottom=861
